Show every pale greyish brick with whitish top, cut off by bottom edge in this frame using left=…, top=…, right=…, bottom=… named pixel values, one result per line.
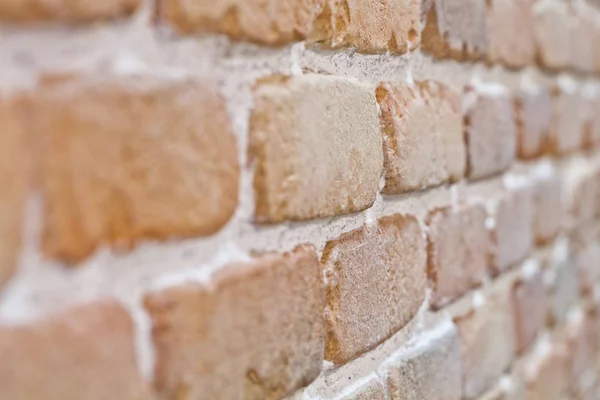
left=383, top=322, right=462, bottom=400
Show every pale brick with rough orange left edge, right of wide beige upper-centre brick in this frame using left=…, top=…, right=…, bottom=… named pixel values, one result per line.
left=377, top=81, right=467, bottom=194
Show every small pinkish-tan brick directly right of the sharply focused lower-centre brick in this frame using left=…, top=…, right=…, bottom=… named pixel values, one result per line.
left=427, top=204, right=490, bottom=308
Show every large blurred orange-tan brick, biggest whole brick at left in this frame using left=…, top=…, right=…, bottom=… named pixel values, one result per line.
left=29, top=76, right=239, bottom=262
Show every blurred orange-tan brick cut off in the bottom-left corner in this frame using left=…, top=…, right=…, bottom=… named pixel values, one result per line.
left=0, top=301, right=153, bottom=400
